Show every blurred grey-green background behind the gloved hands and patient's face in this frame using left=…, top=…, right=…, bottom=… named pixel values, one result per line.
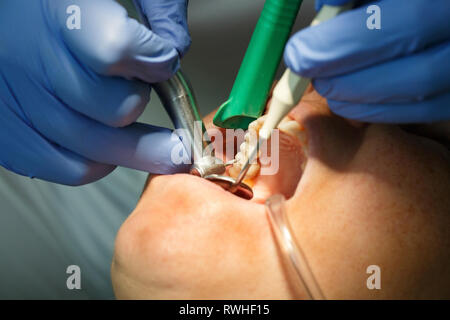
left=0, top=0, right=314, bottom=299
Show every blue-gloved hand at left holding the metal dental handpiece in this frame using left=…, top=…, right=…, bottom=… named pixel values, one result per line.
left=0, top=0, right=190, bottom=185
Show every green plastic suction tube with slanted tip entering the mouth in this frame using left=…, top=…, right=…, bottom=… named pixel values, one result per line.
left=213, top=0, right=303, bottom=129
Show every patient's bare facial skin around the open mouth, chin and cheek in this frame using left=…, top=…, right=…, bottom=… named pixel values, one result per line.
left=111, top=89, right=450, bottom=299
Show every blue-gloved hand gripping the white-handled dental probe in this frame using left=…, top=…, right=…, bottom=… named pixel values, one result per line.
left=284, top=0, right=450, bottom=123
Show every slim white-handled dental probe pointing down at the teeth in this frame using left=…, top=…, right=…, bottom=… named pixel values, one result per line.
left=229, top=2, right=353, bottom=192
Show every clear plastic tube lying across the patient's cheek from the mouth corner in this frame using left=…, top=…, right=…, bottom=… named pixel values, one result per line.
left=266, top=194, right=325, bottom=300
